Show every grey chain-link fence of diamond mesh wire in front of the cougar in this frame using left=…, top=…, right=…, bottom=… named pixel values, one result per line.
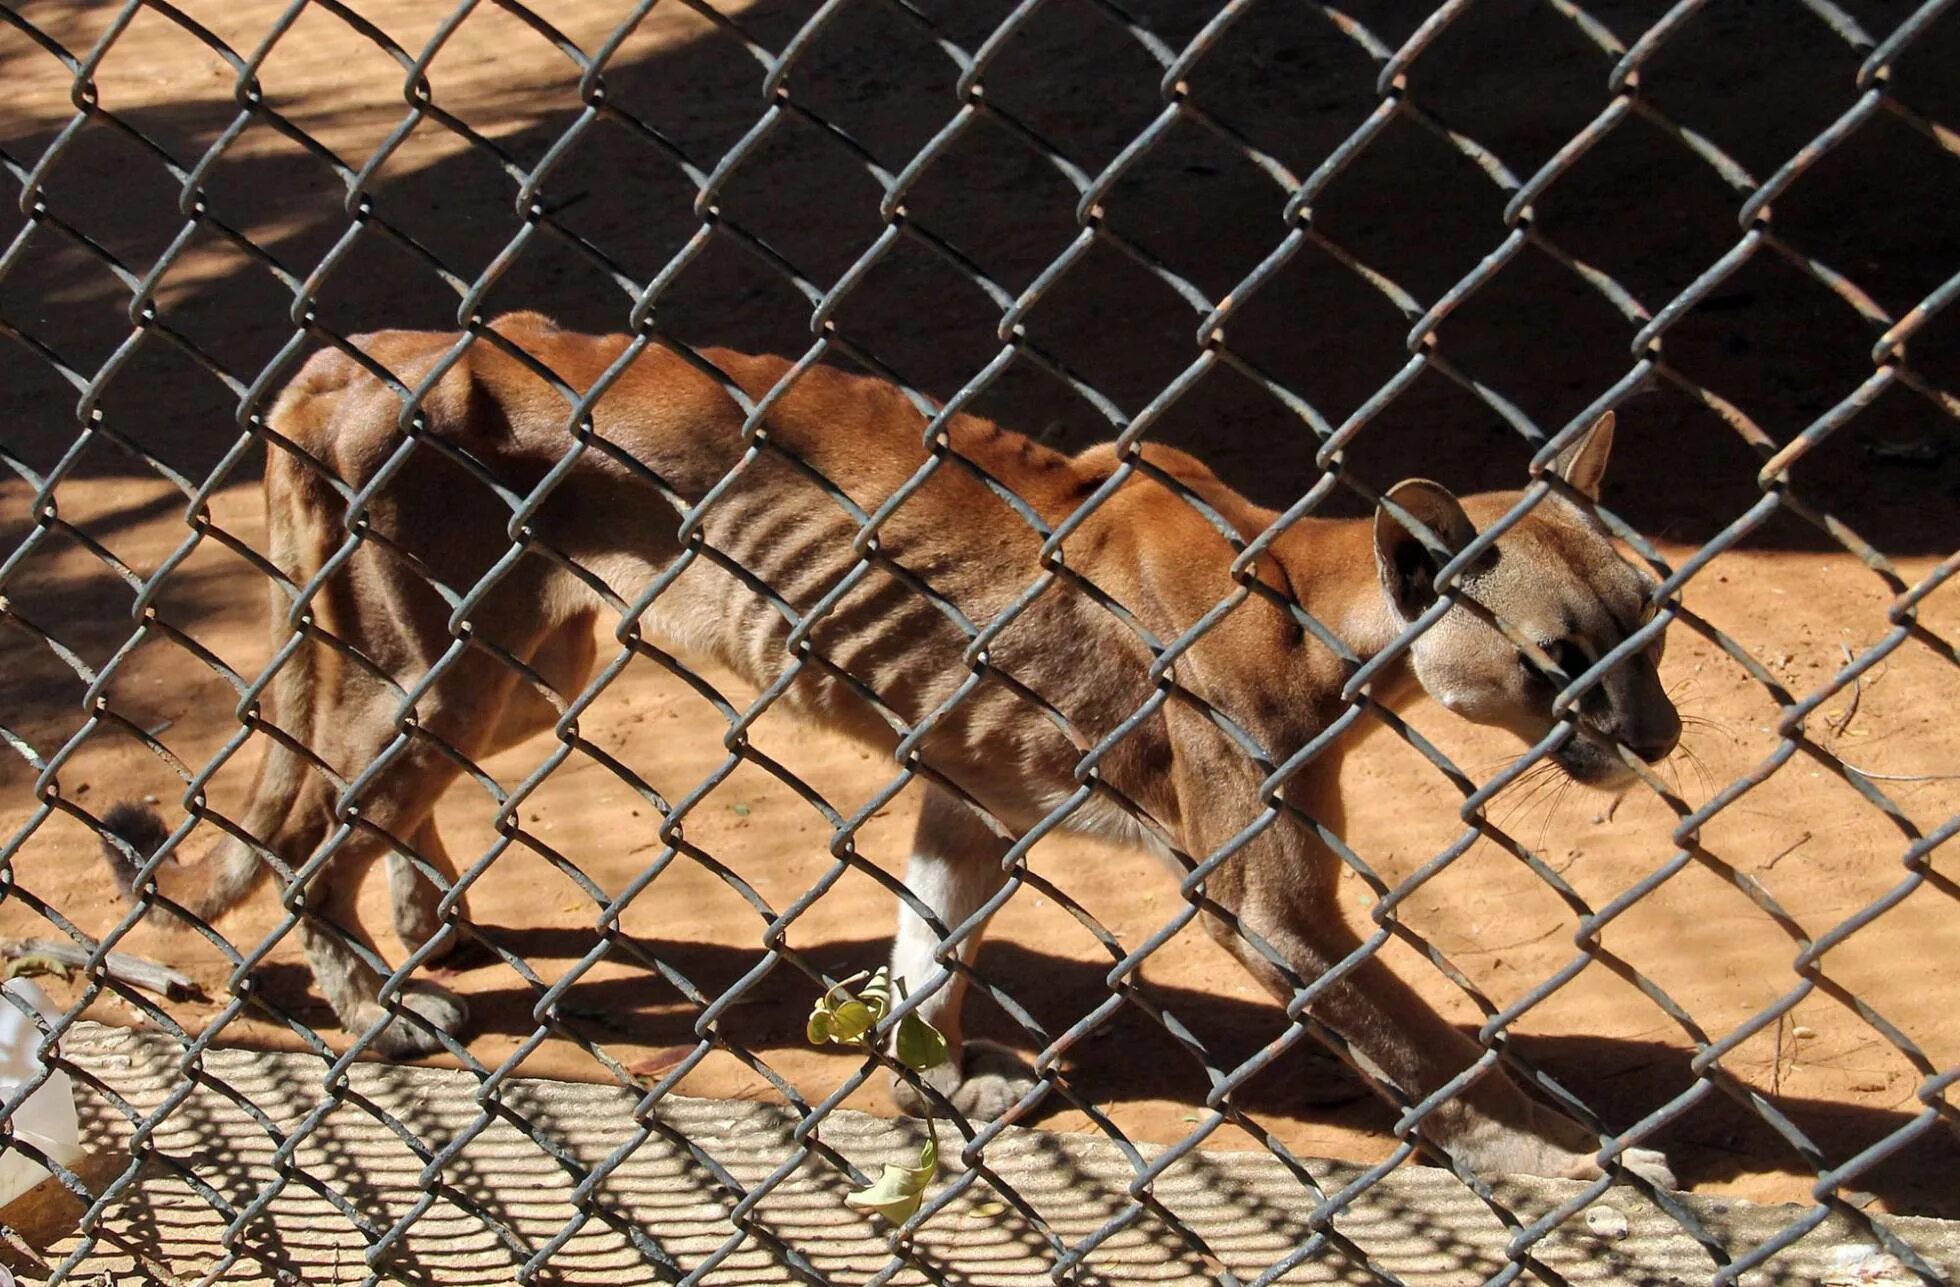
left=0, top=0, right=1960, bottom=1281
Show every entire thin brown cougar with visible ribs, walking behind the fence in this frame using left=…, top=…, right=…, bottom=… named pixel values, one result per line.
left=99, top=313, right=1678, bottom=1179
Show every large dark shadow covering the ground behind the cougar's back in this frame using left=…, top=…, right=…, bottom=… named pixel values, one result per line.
left=0, top=0, right=1960, bottom=540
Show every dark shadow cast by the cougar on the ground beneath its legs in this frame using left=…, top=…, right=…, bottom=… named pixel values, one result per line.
left=237, top=927, right=1960, bottom=1218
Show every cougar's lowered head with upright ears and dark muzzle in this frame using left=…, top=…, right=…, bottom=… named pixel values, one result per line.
left=1374, top=411, right=1682, bottom=786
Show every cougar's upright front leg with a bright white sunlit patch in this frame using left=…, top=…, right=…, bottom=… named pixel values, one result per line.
left=892, top=786, right=1035, bottom=1120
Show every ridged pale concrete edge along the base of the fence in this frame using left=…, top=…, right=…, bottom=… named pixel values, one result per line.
left=0, top=1023, right=1960, bottom=1287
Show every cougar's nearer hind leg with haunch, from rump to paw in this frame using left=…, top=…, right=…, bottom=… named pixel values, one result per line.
left=267, top=333, right=607, bottom=1056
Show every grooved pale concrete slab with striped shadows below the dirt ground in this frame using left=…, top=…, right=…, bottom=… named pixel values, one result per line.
left=6, top=1025, right=1960, bottom=1287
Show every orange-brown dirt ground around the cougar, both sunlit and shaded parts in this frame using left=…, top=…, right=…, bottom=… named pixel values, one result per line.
left=0, top=0, right=1960, bottom=1215
